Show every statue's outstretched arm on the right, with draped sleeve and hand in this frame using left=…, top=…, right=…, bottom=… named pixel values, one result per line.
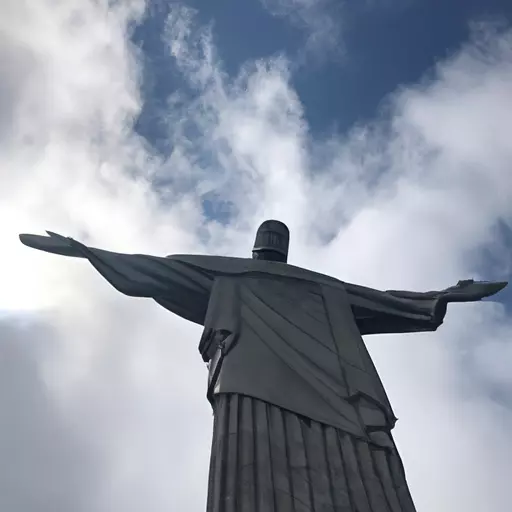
left=344, top=280, right=507, bottom=334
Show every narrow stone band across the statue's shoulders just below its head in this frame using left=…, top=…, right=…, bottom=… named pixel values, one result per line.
left=167, top=254, right=343, bottom=286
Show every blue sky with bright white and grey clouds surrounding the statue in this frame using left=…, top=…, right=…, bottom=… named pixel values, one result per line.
left=0, top=0, right=512, bottom=512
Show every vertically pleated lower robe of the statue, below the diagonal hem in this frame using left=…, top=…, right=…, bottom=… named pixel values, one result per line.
left=207, top=394, right=415, bottom=512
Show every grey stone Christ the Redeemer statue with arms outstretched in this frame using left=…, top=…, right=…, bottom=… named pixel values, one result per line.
left=20, top=220, right=507, bottom=512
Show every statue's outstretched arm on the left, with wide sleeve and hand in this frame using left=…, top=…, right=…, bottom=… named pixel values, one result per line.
left=20, top=232, right=214, bottom=324
